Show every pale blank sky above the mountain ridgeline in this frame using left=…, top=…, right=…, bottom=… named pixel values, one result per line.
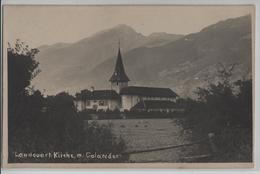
left=3, top=5, right=253, bottom=47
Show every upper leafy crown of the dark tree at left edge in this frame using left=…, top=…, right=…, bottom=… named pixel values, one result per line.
left=8, top=39, right=40, bottom=104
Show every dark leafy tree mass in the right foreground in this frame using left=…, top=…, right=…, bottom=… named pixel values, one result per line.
left=182, top=62, right=252, bottom=162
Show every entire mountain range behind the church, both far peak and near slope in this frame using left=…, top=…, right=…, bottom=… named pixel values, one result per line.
left=31, top=16, right=252, bottom=96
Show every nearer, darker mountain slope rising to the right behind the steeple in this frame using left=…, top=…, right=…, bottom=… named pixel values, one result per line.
left=76, top=16, right=252, bottom=96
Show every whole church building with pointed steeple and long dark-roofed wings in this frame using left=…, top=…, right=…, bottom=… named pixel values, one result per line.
left=74, top=42, right=178, bottom=112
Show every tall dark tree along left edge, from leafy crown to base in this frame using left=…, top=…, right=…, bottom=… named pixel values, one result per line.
left=7, top=39, right=43, bottom=158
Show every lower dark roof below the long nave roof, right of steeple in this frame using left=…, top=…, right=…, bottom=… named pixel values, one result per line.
left=131, top=100, right=177, bottom=110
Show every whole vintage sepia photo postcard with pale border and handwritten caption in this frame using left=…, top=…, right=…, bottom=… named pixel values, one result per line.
left=2, top=5, right=255, bottom=168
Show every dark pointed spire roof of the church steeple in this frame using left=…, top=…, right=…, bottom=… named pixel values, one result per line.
left=109, top=48, right=130, bottom=82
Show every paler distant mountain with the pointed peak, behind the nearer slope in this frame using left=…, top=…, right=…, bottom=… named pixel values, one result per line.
left=32, top=24, right=182, bottom=94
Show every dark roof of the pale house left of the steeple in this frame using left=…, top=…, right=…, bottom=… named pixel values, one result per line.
left=76, top=90, right=120, bottom=100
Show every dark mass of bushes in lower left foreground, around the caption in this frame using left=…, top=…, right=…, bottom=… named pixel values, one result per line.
left=9, top=92, right=128, bottom=162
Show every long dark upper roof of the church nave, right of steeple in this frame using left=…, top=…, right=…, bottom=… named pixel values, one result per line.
left=120, top=86, right=178, bottom=97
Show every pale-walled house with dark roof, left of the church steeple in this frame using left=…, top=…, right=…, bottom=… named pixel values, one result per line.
left=74, top=90, right=121, bottom=111
